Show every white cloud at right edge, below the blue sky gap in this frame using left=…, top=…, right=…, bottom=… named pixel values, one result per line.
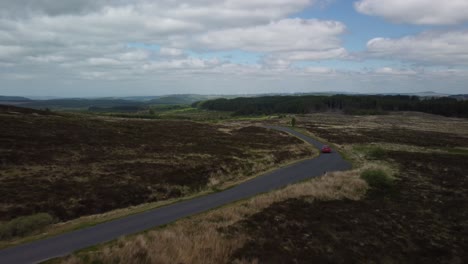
left=367, top=31, right=468, bottom=66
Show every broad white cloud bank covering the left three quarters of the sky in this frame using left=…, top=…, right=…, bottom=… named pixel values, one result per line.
left=0, top=0, right=346, bottom=88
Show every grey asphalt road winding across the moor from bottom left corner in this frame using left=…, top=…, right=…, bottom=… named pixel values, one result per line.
left=0, top=126, right=351, bottom=264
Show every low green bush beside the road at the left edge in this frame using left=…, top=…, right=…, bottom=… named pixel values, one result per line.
left=0, top=213, right=55, bottom=239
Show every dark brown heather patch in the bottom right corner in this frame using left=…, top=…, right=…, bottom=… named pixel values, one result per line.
left=231, top=151, right=468, bottom=263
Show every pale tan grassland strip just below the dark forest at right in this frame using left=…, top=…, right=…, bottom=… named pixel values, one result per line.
left=297, top=113, right=468, bottom=148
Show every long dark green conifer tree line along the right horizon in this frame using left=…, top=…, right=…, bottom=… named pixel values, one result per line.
left=192, top=95, right=468, bottom=117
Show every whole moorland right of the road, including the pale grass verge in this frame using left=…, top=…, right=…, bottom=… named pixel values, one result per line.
left=57, top=113, right=468, bottom=263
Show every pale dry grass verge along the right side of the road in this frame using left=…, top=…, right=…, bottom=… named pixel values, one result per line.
left=62, top=170, right=367, bottom=264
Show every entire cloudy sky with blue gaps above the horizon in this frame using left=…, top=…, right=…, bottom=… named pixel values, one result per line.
left=0, top=0, right=468, bottom=96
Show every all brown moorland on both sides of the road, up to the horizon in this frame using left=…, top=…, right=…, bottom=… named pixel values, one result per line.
left=0, top=94, right=468, bottom=263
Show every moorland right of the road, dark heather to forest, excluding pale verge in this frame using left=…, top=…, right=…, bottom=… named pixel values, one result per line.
left=232, top=113, right=468, bottom=263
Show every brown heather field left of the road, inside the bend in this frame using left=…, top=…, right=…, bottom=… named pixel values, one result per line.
left=0, top=107, right=313, bottom=225
